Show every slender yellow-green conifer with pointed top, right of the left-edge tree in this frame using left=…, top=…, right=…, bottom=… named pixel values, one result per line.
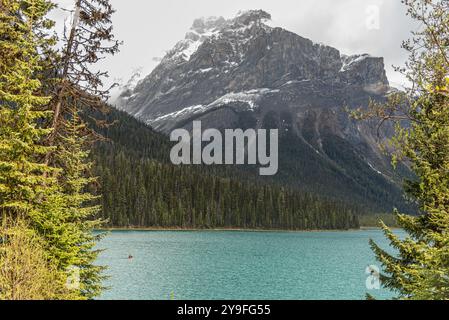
left=50, top=108, right=104, bottom=298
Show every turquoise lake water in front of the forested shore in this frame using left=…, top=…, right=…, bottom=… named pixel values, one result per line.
left=98, top=230, right=400, bottom=300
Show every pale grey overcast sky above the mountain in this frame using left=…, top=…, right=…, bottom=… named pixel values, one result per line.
left=52, top=0, right=414, bottom=87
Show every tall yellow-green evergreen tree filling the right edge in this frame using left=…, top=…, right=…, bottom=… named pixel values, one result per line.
left=364, top=0, right=449, bottom=299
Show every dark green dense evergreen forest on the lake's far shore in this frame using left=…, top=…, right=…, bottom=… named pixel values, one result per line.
left=87, top=109, right=360, bottom=230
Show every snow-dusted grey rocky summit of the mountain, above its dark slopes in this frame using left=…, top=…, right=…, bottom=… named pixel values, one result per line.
left=117, top=10, right=388, bottom=131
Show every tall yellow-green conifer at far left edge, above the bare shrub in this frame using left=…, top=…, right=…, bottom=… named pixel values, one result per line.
left=0, top=0, right=55, bottom=216
